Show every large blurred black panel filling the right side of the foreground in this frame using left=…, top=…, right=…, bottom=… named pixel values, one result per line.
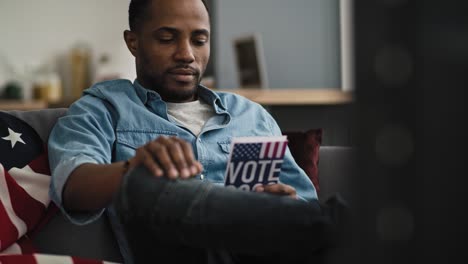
left=349, top=0, right=468, bottom=263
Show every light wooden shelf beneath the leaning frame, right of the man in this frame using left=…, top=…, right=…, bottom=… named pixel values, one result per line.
left=216, top=88, right=353, bottom=105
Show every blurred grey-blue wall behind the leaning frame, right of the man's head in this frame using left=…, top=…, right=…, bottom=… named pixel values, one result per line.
left=215, top=0, right=341, bottom=88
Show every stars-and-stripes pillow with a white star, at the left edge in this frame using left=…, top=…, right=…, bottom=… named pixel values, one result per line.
left=0, top=112, right=50, bottom=254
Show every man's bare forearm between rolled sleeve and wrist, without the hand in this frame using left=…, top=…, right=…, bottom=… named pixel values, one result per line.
left=62, top=162, right=125, bottom=211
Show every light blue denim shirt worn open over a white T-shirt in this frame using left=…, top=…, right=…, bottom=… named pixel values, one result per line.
left=48, top=80, right=317, bottom=262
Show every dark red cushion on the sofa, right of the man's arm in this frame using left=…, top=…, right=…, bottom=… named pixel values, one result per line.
left=283, top=128, right=323, bottom=192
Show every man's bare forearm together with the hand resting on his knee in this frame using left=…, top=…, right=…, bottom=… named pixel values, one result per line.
left=62, top=136, right=203, bottom=211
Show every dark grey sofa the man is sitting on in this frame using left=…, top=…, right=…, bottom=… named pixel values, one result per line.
left=4, top=108, right=355, bottom=262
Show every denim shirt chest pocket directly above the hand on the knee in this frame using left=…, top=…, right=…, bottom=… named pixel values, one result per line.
left=116, top=130, right=177, bottom=150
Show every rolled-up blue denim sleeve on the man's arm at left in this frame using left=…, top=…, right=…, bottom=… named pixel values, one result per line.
left=48, top=95, right=115, bottom=225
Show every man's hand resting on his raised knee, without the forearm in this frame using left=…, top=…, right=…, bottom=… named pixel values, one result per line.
left=129, top=136, right=203, bottom=179
